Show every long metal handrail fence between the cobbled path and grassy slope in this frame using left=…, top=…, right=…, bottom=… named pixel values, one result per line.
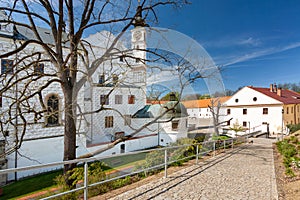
left=0, top=137, right=248, bottom=199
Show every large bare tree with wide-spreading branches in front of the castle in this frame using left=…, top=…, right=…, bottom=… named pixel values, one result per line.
left=0, top=0, right=225, bottom=188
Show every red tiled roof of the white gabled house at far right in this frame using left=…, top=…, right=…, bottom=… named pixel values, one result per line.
left=248, top=86, right=300, bottom=104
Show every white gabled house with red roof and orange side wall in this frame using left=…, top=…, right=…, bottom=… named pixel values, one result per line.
left=223, top=84, right=300, bottom=134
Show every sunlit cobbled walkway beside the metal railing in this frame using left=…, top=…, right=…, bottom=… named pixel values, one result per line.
left=107, top=138, right=278, bottom=200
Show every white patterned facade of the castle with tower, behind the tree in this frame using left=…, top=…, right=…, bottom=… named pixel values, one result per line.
left=0, top=13, right=186, bottom=180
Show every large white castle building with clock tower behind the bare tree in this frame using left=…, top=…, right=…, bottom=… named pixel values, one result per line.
left=0, top=11, right=187, bottom=183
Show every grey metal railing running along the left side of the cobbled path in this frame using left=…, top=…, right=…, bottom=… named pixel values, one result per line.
left=0, top=136, right=248, bottom=200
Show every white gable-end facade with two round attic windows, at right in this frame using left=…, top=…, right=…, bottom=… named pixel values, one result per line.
left=222, top=87, right=283, bottom=133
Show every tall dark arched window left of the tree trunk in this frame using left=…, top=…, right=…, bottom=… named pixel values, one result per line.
left=46, top=94, right=59, bottom=126
